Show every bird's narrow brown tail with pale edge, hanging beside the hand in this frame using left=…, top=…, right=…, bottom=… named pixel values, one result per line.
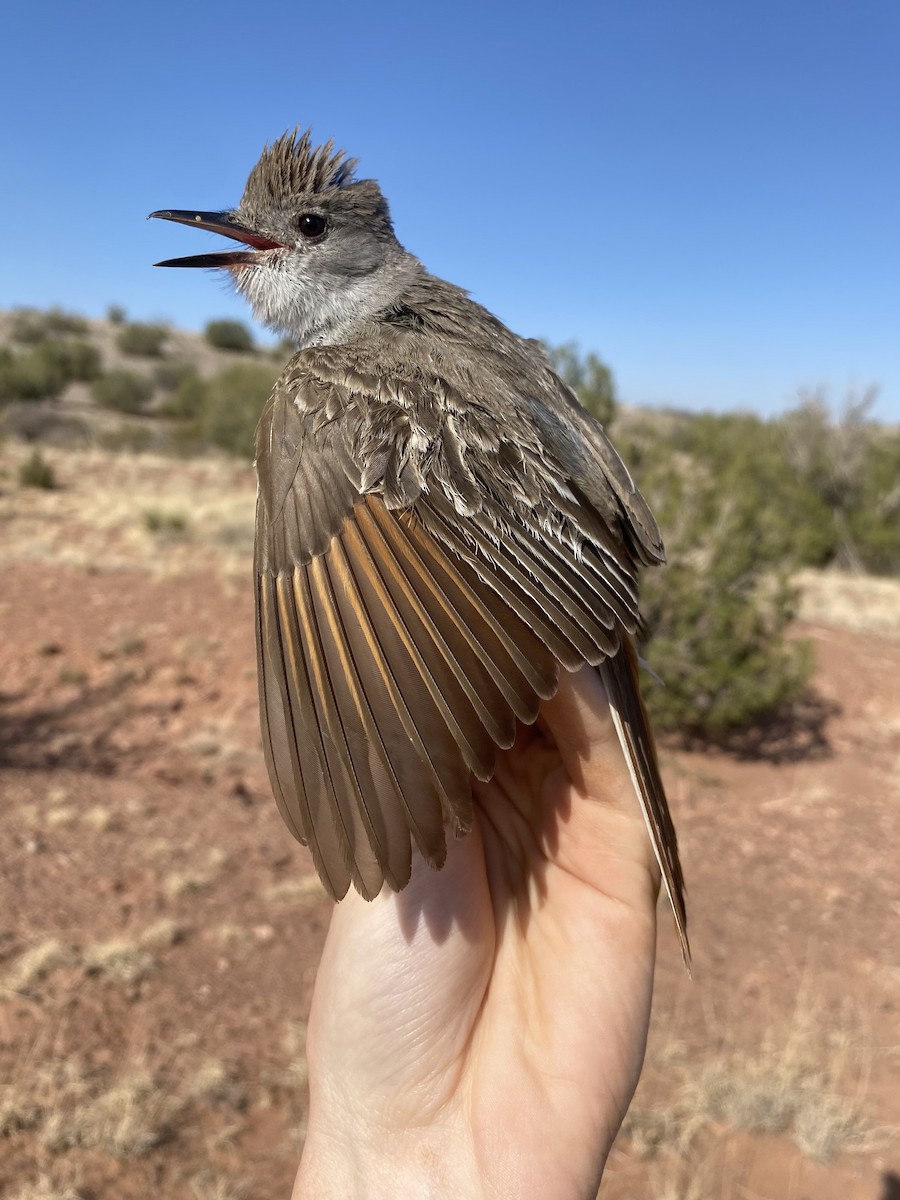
left=600, top=638, right=691, bottom=972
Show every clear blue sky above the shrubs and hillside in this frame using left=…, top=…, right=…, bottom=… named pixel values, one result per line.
left=0, top=0, right=900, bottom=420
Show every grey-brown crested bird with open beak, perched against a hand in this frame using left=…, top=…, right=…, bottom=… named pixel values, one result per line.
left=150, top=127, right=690, bottom=965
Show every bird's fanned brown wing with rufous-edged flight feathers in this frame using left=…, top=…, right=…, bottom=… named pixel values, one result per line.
left=250, top=360, right=683, bottom=964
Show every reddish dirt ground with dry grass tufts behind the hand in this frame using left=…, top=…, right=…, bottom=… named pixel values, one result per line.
left=0, top=440, right=900, bottom=1200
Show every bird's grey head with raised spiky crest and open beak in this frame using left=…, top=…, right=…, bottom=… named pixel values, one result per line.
left=150, top=130, right=415, bottom=346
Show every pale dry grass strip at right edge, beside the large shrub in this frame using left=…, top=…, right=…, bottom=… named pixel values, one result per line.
left=797, top=570, right=900, bottom=638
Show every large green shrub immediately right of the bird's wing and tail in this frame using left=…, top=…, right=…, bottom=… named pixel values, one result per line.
left=623, top=414, right=811, bottom=740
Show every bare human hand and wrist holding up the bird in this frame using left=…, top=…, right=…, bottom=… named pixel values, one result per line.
left=293, top=668, right=659, bottom=1200
